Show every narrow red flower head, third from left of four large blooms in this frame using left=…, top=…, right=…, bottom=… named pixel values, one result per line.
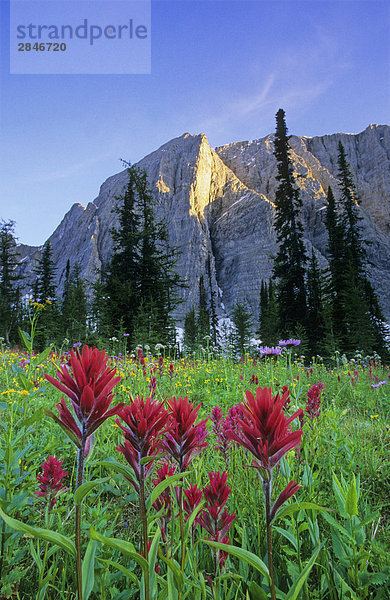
left=163, top=396, right=208, bottom=472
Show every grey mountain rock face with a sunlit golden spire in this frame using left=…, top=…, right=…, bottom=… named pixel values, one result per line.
left=20, top=125, right=390, bottom=320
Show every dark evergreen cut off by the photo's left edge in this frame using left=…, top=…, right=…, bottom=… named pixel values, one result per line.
left=0, top=221, right=19, bottom=344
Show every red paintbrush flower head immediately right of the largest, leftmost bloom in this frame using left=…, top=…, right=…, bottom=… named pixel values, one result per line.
left=116, top=396, right=168, bottom=491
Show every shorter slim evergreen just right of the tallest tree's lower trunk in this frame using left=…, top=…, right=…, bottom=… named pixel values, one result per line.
left=307, top=249, right=328, bottom=356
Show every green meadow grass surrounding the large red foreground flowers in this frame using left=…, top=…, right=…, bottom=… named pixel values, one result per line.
left=0, top=349, right=390, bottom=600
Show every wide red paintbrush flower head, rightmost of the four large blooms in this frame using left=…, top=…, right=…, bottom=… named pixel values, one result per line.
left=227, top=388, right=303, bottom=480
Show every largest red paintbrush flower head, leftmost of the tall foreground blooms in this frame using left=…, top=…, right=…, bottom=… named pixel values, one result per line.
left=45, top=346, right=123, bottom=448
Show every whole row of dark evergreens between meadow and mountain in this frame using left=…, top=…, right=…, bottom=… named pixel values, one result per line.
left=0, top=114, right=387, bottom=356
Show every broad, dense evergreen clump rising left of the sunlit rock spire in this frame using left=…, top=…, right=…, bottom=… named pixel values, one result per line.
left=99, top=166, right=181, bottom=343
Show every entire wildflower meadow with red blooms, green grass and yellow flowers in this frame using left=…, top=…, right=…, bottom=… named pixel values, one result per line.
left=0, top=340, right=390, bottom=600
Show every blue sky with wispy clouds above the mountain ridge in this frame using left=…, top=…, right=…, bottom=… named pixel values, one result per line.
left=0, top=0, right=390, bottom=245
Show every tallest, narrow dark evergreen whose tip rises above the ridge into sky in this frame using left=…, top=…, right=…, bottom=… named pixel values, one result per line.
left=273, top=109, right=307, bottom=336
